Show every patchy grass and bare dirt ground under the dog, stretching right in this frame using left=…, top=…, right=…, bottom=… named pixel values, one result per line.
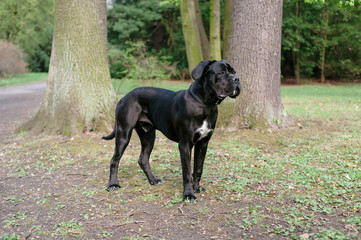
left=0, top=83, right=361, bottom=239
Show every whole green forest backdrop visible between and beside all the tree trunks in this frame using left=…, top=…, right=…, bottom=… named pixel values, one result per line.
left=0, top=0, right=361, bottom=83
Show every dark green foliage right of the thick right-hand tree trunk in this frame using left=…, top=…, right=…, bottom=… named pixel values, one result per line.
left=282, top=0, right=361, bottom=80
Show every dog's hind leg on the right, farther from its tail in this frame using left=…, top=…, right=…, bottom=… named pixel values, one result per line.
left=135, top=124, right=164, bottom=185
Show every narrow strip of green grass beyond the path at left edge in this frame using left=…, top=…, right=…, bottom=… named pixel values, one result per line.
left=0, top=73, right=48, bottom=87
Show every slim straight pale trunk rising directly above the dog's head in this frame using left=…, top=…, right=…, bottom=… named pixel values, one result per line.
left=209, top=0, right=222, bottom=60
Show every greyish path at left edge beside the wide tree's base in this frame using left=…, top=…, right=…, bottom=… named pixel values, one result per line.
left=0, top=82, right=46, bottom=143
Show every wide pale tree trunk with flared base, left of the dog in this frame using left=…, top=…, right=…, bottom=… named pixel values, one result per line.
left=24, top=0, right=116, bottom=136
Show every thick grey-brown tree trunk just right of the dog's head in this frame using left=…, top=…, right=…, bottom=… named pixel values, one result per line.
left=225, top=0, right=291, bottom=128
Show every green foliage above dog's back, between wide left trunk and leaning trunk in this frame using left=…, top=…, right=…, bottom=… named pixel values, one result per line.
left=108, top=0, right=187, bottom=80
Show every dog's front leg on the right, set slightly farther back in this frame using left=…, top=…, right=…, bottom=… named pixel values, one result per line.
left=193, top=140, right=208, bottom=193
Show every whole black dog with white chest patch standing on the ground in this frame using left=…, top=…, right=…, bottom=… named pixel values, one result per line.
left=103, top=60, right=241, bottom=201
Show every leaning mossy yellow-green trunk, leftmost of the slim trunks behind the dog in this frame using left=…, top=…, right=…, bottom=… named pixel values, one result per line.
left=180, top=0, right=203, bottom=72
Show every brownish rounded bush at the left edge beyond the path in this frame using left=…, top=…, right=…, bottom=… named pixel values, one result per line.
left=0, top=41, right=28, bottom=77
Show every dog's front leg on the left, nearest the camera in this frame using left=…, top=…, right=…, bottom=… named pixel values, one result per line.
left=178, top=142, right=197, bottom=202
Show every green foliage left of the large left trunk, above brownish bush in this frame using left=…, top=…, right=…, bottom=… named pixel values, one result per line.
left=0, top=0, right=55, bottom=72
